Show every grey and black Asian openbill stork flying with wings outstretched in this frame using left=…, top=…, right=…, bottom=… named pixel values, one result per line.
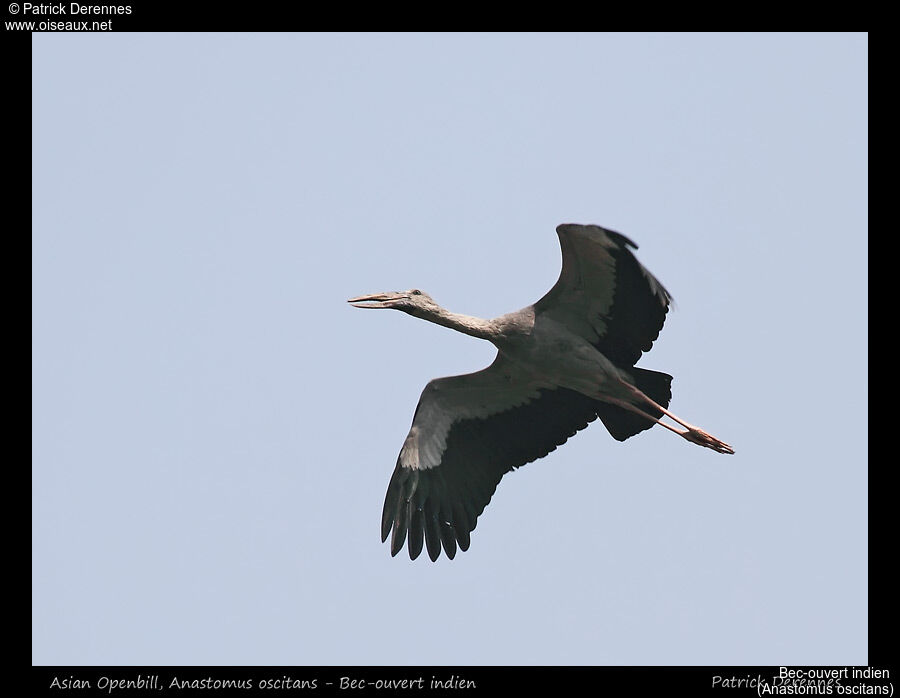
left=348, top=224, right=734, bottom=560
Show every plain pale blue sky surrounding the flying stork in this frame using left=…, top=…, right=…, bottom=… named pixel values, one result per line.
left=32, top=34, right=868, bottom=665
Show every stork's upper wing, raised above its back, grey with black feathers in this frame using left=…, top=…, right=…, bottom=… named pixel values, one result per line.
left=534, top=224, right=672, bottom=367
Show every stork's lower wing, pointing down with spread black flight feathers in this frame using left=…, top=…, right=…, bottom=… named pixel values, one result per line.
left=381, top=354, right=604, bottom=560
